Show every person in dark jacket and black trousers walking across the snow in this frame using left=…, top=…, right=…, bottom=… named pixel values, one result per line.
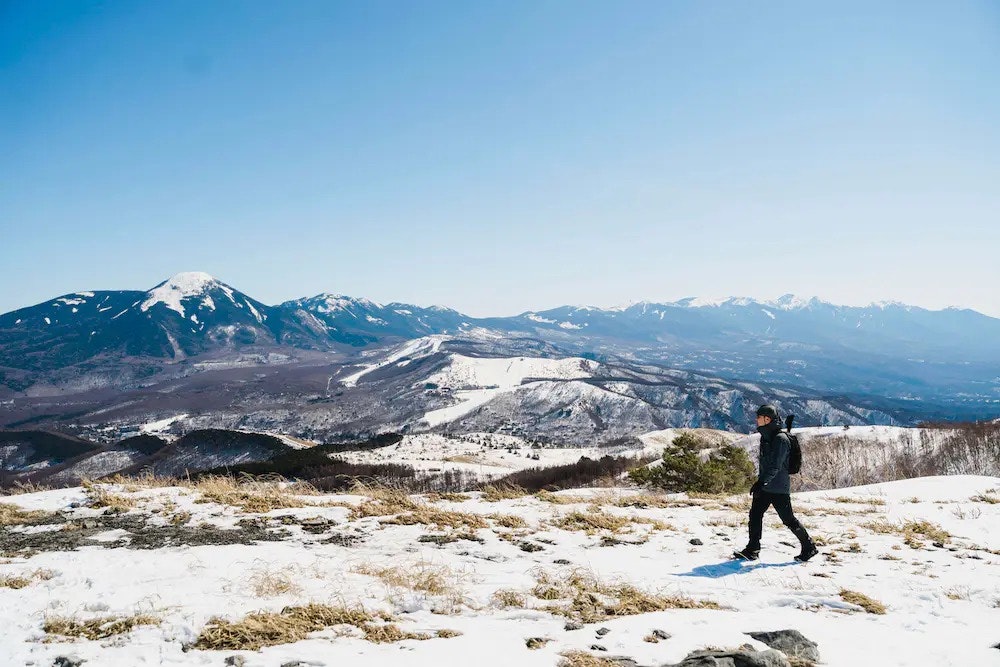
left=733, top=405, right=818, bottom=562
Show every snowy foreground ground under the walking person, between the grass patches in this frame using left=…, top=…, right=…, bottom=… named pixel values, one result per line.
left=0, top=477, right=1000, bottom=667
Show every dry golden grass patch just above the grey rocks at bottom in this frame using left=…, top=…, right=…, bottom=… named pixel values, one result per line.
left=531, top=570, right=722, bottom=623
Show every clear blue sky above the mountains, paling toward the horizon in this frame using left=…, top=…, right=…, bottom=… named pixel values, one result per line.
left=0, top=0, right=1000, bottom=316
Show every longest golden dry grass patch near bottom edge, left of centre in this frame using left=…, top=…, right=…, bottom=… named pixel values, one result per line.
left=194, top=604, right=457, bottom=651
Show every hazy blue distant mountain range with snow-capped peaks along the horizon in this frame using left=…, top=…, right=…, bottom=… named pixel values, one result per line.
left=0, top=273, right=1000, bottom=434
